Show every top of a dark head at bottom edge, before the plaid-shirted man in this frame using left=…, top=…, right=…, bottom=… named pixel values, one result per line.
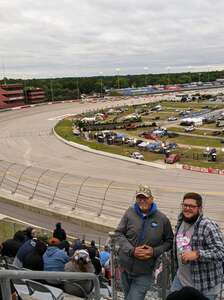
left=166, top=286, right=209, bottom=300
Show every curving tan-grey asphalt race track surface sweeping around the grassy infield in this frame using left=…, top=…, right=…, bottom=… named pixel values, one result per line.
left=0, top=99, right=224, bottom=229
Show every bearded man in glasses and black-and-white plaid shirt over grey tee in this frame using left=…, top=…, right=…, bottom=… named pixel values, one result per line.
left=171, top=193, right=224, bottom=300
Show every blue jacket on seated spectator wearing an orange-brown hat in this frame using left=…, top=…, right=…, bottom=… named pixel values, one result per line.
left=43, top=246, right=69, bottom=272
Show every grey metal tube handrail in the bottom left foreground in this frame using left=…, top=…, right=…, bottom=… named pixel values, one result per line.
left=0, top=270, right=100, bottom=300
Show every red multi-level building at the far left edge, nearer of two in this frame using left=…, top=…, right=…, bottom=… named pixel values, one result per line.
left=0, top=84, right=25, bottom=109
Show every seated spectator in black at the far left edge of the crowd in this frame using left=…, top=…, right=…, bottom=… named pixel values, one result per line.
left=1, top=230, right=25, bottom=257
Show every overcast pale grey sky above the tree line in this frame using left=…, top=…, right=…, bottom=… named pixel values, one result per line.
left=0, top=0, right=224, bottom=78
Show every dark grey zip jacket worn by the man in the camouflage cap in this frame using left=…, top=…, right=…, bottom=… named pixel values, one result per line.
left=115, top=203, right=173, bottom=275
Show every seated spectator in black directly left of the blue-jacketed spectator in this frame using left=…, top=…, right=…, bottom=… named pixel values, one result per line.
left=23, top=240, right=47, bottom=271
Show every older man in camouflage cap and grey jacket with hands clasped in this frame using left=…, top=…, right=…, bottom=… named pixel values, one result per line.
left=115, top=186, right=173, bottom=300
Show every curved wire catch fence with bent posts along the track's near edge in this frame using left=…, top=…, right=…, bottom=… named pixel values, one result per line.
left=0, top=161, right=224, bottom=230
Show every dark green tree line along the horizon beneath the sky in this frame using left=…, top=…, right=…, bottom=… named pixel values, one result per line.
left=0, top=70, right=224, bottom=101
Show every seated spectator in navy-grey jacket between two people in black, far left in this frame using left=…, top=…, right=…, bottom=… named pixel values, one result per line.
left=13, top=227, right=37, bottom=268
